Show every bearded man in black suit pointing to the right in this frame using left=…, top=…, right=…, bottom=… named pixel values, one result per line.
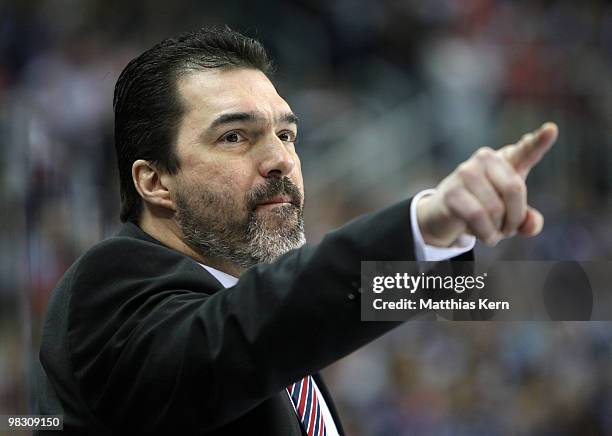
left=38, top=29, right=557, bottom=435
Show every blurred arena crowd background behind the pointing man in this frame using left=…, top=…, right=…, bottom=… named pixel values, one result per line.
left=0, top=0, right=612, bottom=436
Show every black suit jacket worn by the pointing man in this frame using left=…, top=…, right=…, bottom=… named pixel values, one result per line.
left=37, top=201, right=468, bottom=436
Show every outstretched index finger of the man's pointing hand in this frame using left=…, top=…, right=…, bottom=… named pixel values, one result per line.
left=500, top=122, right=559, bottom=178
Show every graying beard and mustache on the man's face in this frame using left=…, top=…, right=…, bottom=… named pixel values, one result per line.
left=176, top=178, right=306, bottom=268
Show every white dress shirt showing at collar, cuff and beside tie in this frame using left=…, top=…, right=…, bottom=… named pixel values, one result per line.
left=200, top=189, right=476, bottom=436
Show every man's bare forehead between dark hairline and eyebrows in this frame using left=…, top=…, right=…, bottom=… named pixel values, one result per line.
left=177, top=68, right=290, bottom=123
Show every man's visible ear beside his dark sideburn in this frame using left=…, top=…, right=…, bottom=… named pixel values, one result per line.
left=132, top=159, right=176, bottom=211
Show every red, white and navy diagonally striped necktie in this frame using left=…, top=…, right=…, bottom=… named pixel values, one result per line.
left=287, top=376, right=326, bottom=436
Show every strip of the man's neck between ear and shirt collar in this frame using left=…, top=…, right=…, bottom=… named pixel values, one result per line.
left=138, top=212, right=245, bottom=277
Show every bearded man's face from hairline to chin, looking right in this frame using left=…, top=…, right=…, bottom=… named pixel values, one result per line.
left=173, top=68, right=305, bottom=268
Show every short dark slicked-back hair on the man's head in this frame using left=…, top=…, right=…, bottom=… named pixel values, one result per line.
left=113, top=27, right=272, bottom=222
